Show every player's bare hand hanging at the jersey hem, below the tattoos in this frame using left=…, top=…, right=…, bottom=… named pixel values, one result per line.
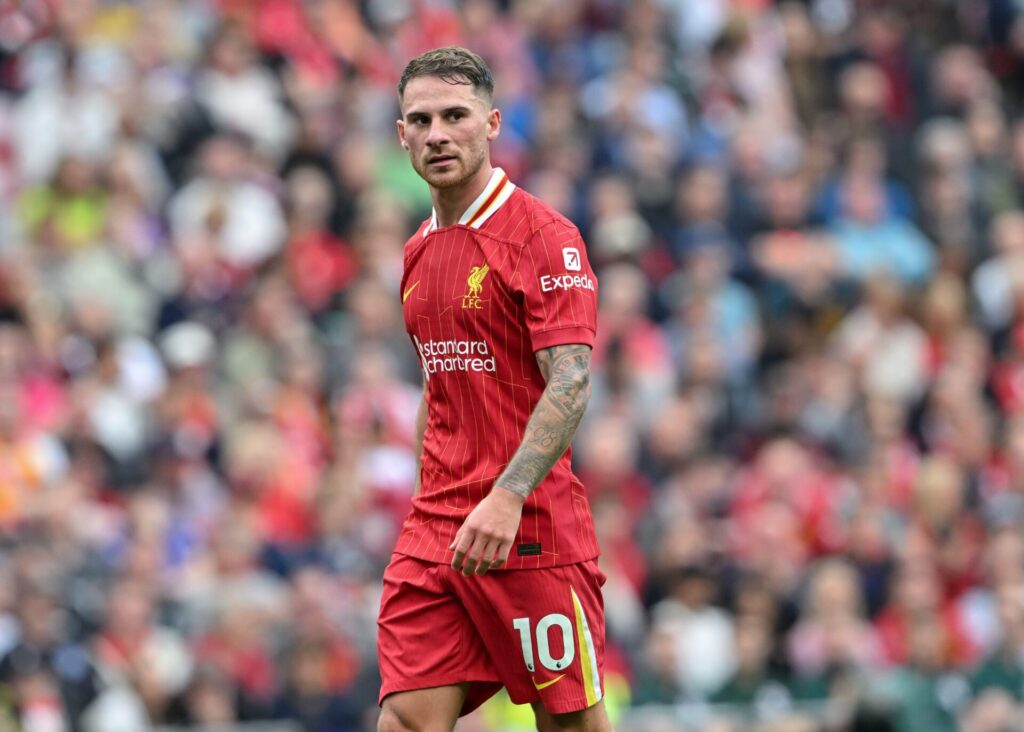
left=449, top=485, right=525, bottom=577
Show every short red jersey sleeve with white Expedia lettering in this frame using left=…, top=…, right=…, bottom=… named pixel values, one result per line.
left=519, top=221, right=597, bottom=352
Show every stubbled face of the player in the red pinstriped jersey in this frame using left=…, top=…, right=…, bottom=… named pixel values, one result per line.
left=397, top=77, right=502, bottom=188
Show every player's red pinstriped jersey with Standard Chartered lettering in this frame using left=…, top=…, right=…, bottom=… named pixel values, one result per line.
left=395, top=168, right=598, bottom=569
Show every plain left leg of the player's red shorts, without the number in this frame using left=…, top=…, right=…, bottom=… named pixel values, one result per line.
left=377, top=555, right=501, bottom=720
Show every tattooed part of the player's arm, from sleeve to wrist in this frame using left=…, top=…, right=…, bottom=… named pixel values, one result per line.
left=496, top=344, right=590, bottom=499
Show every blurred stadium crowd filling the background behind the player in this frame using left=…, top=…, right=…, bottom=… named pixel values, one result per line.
left=0, top=0, right=1024, bottom=732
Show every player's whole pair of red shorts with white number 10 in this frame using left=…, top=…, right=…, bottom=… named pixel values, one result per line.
left=377, top=554, right=605, bottom=715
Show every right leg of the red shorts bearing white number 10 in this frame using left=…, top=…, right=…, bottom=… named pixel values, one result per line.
left=449, top=561, right=604, bottom=715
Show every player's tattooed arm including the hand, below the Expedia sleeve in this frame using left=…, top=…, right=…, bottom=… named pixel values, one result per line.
left=449, top=344, right=591, bottom=576
